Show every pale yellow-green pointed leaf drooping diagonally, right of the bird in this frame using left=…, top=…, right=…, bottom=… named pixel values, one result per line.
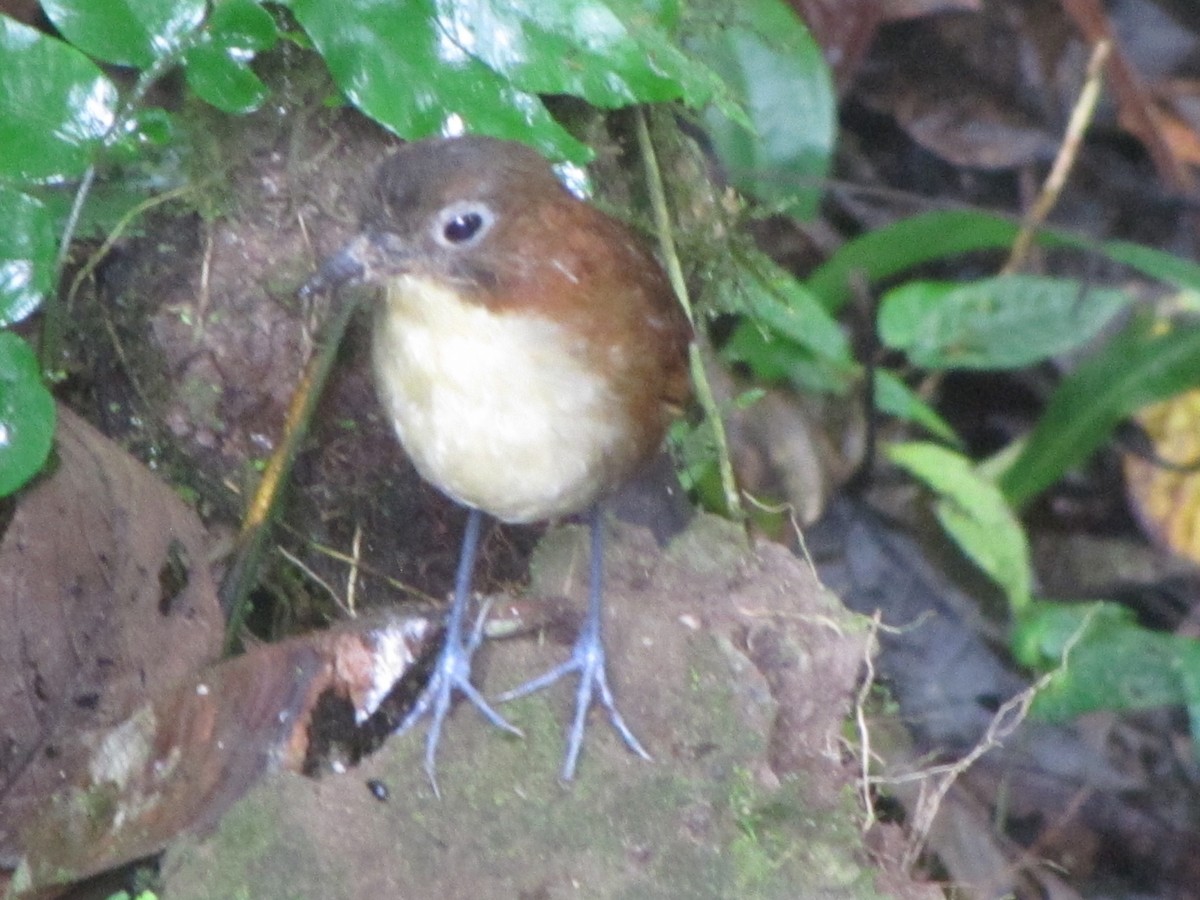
left=888, top=443, right=1033, bottom=611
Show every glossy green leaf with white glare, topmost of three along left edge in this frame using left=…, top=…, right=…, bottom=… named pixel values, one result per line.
left=0, top=16, right=116, bottom=181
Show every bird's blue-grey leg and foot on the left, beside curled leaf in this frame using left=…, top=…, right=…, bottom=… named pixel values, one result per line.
left=396, top=509, right=522, bottom=796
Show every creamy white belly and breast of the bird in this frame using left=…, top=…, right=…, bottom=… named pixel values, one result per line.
left=374, top=276, right=622, bottom=522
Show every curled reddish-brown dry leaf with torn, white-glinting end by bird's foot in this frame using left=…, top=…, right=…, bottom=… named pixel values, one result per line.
left=14, top=617, right=433, bottom=899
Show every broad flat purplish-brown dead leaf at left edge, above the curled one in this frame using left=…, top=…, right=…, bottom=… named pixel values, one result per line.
left=0, top=409, right=223, bottom=866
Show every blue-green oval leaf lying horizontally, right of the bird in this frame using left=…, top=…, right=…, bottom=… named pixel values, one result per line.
left=878, top=275, right=1129, bottom=368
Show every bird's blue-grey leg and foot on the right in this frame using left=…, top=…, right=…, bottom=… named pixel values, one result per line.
left=497, top=504, right=650, bottom=781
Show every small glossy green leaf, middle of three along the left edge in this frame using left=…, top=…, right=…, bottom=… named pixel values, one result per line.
left=0, top=185, right=55, bottom=326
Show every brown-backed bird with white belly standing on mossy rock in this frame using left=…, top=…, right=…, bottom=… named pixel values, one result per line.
left=302, top=136, right=694, bottom=793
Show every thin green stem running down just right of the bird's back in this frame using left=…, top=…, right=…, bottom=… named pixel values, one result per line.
left=635, top=107, right=746, bottom=522
